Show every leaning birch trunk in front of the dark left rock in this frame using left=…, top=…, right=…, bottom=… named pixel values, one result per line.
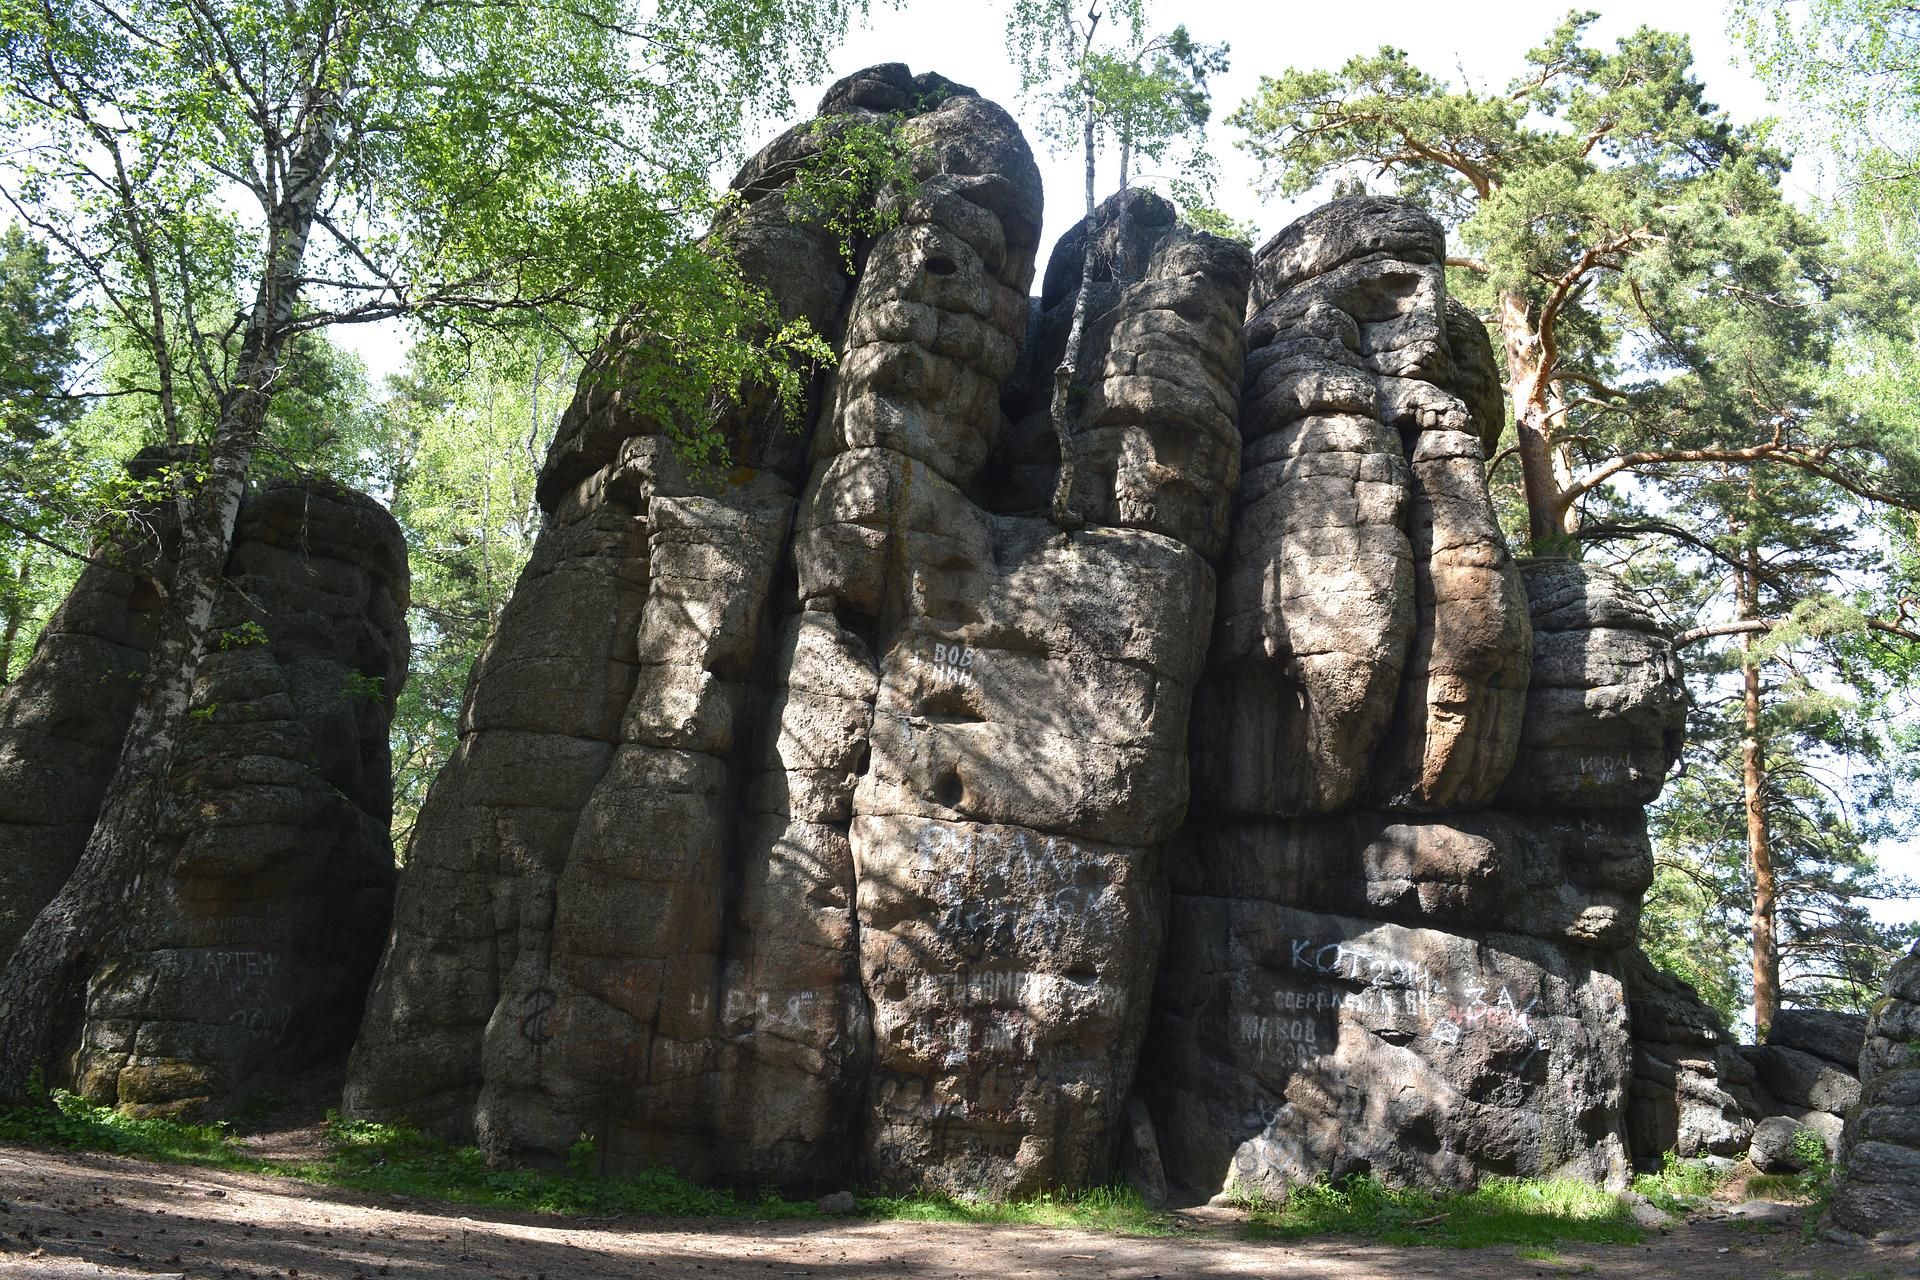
left=0, top=112, right=334, bottom=1102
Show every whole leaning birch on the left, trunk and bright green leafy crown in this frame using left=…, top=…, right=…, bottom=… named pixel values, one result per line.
left=0, top=0, right=875, bottom=1098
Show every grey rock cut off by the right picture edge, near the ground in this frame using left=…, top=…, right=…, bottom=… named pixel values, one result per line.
left=1826, top=942, right=1920, bottom=1244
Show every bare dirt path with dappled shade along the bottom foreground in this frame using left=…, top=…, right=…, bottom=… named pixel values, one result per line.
left=0, top=1146, right=1920, bottom=1280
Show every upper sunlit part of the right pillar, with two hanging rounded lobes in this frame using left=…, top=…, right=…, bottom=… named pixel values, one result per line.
left=1196, top=200, right=1530, bottom=816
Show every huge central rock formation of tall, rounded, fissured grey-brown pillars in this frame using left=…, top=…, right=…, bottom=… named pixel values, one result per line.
left=337, top=65, right=1684, bottom=1194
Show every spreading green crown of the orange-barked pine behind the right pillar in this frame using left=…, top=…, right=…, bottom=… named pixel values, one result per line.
left=1231, top=13, right=1920, bottom=551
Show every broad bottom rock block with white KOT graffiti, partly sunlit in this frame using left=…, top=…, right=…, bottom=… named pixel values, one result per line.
left=1146, top=894, right=1628, bottom=1194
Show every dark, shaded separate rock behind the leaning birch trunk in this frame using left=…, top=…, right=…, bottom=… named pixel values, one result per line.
left=0, top=482, right=407, bottom=1109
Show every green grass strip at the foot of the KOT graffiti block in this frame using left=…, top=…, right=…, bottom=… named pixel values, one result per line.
left=1246, top=1176, right=1640, bottom=1249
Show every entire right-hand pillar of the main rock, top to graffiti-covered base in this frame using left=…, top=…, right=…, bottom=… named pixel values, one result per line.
left=1142, top=198, right=1684, bottom=1196
